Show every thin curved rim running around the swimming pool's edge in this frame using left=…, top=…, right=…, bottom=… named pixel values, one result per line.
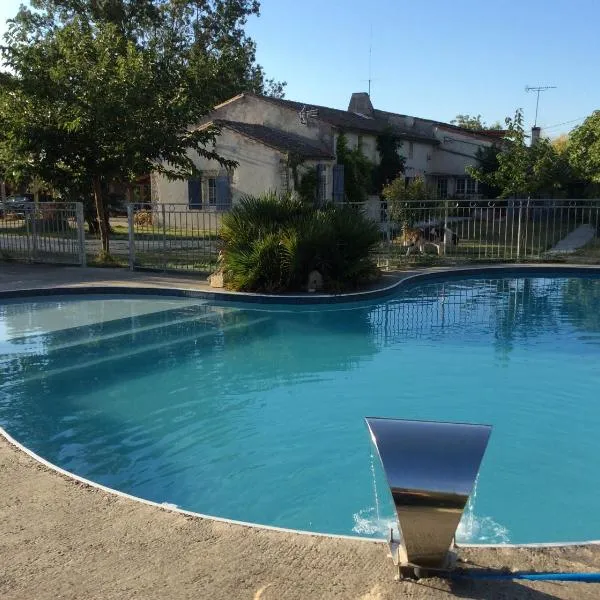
left=0, top=263, right=600, bottom=550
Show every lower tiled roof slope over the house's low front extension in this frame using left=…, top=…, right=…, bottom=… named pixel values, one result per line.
left=213, top=119, right=335, bottom=160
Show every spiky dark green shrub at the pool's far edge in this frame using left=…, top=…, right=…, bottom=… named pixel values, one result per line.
left=221, top=193, right=380, bottom=292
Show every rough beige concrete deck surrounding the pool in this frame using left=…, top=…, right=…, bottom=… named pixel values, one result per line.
left=0, top=263, right=600, bottom=600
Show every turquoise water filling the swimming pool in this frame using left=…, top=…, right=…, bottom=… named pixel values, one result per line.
left=0, top=278, right=600, bottom=543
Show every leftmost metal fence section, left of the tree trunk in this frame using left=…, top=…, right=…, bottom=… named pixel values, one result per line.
left=0, top=201, right=86, bottom=266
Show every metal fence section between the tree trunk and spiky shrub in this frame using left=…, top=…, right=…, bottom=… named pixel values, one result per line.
left=127, top=204, right=222, bottom=273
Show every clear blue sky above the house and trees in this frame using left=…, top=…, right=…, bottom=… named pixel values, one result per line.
left=0, top=0, right=600, bottom=137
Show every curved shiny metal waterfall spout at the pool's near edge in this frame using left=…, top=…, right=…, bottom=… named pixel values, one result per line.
left=366, top=417, right=492, bottom=573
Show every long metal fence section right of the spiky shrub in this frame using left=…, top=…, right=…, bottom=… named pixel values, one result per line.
left=352, top=200, right=600, bottom=267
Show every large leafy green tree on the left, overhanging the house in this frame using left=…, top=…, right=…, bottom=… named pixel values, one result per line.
left=0, top=0, right=283, bottom=253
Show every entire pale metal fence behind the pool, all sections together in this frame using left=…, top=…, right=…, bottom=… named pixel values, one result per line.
left=0, top=198, right=600, bottom=273
